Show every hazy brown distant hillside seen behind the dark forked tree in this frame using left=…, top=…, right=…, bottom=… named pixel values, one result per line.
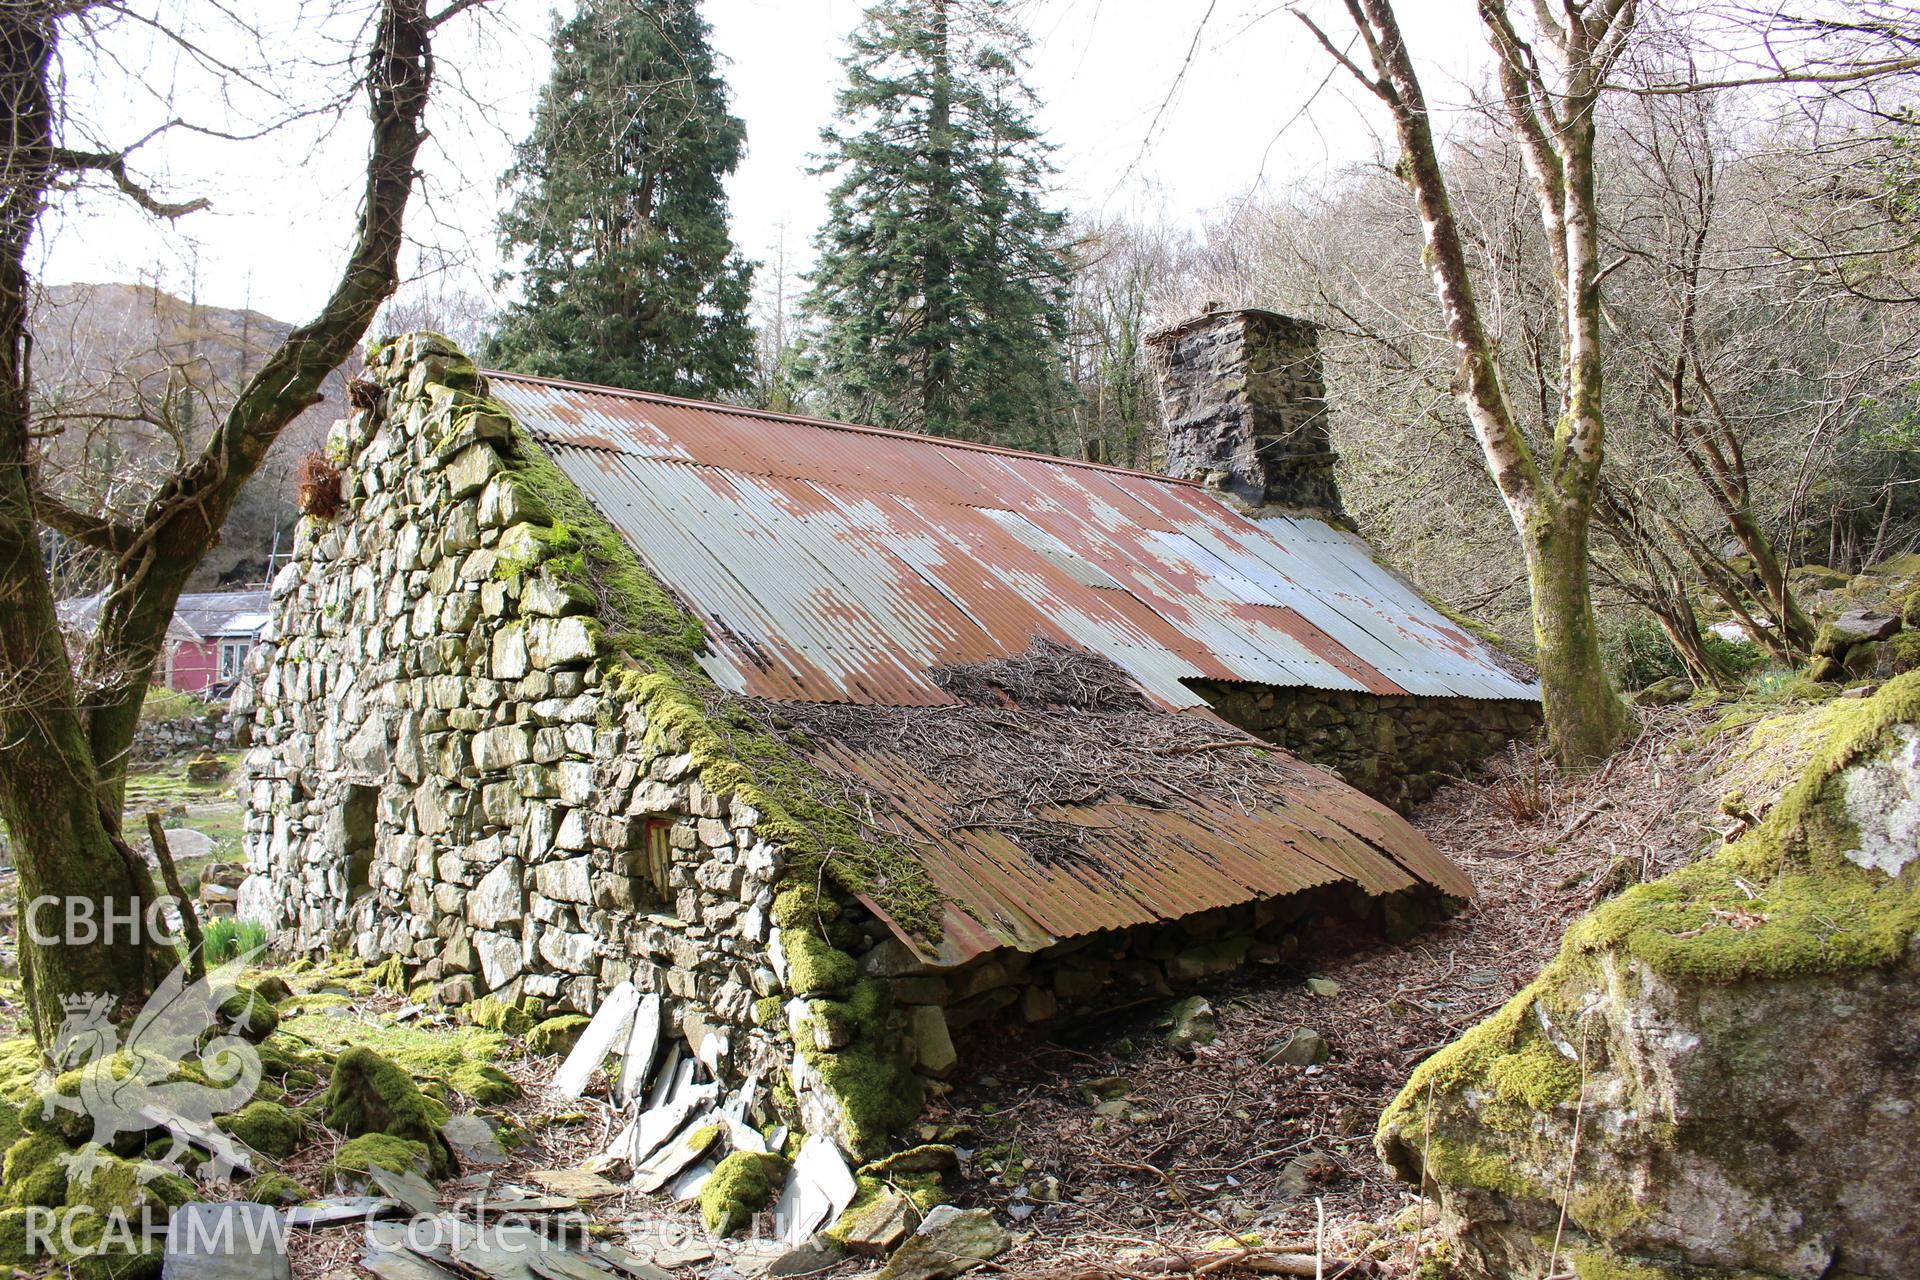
left=31, top=284, right=359, bottom=589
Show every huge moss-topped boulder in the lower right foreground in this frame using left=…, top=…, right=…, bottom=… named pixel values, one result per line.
left=1377, top=674, right=1920, bottom=1278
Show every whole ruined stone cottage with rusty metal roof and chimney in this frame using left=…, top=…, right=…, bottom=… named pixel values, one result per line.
left=236, top=311, right=1538, bottom=1155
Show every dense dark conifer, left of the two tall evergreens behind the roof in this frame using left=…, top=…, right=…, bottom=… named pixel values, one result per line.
left=490, top=0, right=753, bottom=397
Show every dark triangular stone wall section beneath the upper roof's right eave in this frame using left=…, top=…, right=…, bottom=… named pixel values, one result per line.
left=1192, top=681, right=1540, bottom=812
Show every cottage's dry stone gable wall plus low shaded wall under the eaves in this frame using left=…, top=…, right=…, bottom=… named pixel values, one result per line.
left=234, top=334, right=1497, bottom=1159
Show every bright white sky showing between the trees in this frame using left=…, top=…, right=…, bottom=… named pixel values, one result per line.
left=40, top=0, right=1484, bottom=320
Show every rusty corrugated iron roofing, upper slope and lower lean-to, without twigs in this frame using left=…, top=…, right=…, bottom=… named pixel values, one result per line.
left=490, top=374, right=1538, bottom=965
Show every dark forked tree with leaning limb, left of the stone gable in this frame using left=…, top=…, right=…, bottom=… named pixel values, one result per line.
left=0, top=0, right=439, bottom=1044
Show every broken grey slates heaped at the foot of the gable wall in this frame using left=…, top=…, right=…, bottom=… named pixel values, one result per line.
left=163, top=983, right=1008, bottom=1280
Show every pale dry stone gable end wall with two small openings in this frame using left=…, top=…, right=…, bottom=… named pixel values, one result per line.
left=236, top=334, right=825, bottom=1136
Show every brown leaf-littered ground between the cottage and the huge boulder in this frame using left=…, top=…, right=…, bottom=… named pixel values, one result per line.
left=933, top=706, right=1743, bottom=1276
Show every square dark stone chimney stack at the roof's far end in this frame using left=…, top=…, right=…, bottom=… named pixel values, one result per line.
left=1146, top=303, right=1346, bottom=520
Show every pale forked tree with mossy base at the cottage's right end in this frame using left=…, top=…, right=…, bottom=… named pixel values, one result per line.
left=1298, top=0, right=1636, bottom=766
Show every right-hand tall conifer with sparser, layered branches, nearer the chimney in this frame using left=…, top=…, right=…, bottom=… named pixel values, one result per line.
left=806, top=0, right=1069, bottom=451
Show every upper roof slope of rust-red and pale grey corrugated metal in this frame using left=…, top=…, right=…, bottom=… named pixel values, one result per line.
left=490, top=374, right=1538, bottom=708
